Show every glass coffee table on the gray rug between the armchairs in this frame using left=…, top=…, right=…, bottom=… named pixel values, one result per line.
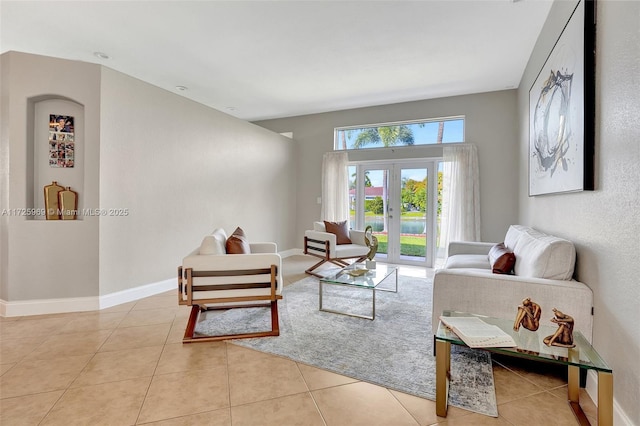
left=318, top=263, right=398, bottom=320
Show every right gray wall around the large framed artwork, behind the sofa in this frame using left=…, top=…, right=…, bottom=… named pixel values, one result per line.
left=518, top=1, right=640, bottom=424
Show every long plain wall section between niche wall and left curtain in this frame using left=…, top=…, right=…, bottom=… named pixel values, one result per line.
left=100, top=68, right=296, bottom=294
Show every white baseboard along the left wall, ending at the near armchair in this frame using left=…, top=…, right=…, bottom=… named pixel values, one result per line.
left=0, top=278, right=178, bottom=317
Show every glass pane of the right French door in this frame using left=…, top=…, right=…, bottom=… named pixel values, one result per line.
left=400, top=168, right=428, bottom=260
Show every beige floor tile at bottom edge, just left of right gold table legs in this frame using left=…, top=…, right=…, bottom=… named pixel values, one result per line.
left=498, top=392, right=576, bottom=426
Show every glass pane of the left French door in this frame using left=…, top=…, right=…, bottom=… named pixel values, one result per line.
left=364, top=169, right=389, bottom=258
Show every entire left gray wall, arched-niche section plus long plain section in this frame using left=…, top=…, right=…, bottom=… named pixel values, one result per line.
left=0, top=52, right=297, bottom=302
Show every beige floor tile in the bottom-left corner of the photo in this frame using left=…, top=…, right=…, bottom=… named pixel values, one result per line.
left=0, top=390, right=64, bottom=426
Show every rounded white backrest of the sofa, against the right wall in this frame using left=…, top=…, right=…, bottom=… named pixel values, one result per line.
left=505, top=225, right=576, bottom=280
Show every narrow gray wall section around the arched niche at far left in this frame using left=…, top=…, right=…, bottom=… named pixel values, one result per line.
left=0, top=52, right=100, bottom=301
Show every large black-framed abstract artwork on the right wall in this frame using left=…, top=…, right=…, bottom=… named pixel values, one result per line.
left=529, top=0, right=596, bottom=196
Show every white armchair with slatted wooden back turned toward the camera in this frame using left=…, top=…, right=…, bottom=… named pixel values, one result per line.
left=178, top=228, right=283, bottom=343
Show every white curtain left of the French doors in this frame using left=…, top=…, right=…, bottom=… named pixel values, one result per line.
left=321, top=151, right=349, bottom=222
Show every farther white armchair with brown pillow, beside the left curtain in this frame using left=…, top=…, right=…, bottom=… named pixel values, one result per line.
left=304, top=222, right=370, bottom=277
